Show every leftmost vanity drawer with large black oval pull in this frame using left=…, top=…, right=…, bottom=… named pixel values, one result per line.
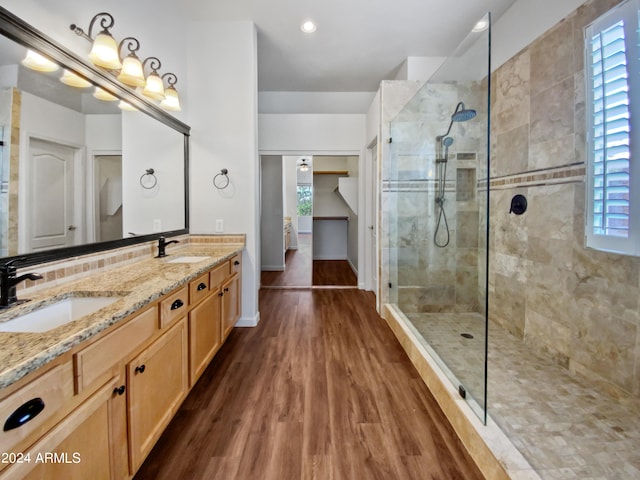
left=0, top=361, right=73, bottom=458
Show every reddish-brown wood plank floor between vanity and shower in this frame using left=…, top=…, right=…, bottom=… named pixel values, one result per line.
left=135, top=289, right=483, bottom=480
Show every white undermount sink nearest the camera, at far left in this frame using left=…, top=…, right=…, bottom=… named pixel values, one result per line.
left=0, top=296, right=121, bottom=333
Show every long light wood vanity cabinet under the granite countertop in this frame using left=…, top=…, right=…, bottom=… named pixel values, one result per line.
left=0, top=255, right=242, bottom=480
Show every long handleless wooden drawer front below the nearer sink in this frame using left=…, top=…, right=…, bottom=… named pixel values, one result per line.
left=74, top=307, right=158, bottom=393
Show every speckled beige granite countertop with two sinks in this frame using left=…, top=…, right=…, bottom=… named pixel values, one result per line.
left=0, top=244, right=243, bottom=388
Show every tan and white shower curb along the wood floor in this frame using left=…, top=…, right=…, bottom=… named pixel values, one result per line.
left=382, top=304, right=540, bottom=480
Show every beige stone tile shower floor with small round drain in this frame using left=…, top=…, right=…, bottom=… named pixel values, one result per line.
left=407, top=314, right=640, bottom=480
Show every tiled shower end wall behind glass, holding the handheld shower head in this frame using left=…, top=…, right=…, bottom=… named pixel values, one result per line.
left=383, top=82, right=487, bottom=313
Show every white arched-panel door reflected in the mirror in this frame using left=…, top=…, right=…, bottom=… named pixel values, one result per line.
left=27, top=139, right=76, bottom=252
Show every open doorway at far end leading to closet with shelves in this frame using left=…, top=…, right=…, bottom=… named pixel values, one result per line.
left=261, top=155, right=359, bottom=288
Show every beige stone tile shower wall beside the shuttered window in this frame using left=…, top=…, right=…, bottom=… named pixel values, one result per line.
left=489, top=0, right=640, bottom=396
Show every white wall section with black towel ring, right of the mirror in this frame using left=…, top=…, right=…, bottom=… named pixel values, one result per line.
left=188, top=21, right=260, bottom=325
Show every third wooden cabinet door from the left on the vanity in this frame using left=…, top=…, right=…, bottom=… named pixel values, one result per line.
left=189, top=290, right=221, bottom=386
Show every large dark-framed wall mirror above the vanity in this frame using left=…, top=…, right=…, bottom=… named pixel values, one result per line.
left=0, top=7, right=189, bottom=265
